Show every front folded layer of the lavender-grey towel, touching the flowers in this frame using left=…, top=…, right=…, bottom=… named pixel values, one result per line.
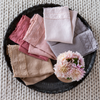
left=48, top=29, right=97, bottom=57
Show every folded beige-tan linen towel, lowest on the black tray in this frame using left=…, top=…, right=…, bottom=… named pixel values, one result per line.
left=8, top=45, right=53, bottom=85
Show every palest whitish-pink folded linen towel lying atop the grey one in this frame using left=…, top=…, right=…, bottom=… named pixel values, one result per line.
left=43, top=7, right=77, bottom=44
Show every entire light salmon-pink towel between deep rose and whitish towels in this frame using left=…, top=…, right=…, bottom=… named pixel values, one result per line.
left=23, top=14, right=56, bottom=60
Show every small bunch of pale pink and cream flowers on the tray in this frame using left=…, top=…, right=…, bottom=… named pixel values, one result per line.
left=54, top=51, right=85, bottom=81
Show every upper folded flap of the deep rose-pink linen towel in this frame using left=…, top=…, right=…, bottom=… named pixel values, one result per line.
left=9, top=15, right=30, bottom=45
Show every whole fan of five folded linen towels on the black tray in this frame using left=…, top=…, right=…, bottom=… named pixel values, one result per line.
left=8, top=7, right=97, bottom=85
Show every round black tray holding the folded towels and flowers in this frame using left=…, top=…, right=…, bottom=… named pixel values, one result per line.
left=3, top=4, right=96, bottom=93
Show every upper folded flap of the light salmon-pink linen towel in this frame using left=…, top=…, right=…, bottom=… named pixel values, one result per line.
left=24, top=14, right=44, bottom=46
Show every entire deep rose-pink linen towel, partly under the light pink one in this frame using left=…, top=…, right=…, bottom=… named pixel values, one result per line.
left=9, top=15, right=48, bottom=61
